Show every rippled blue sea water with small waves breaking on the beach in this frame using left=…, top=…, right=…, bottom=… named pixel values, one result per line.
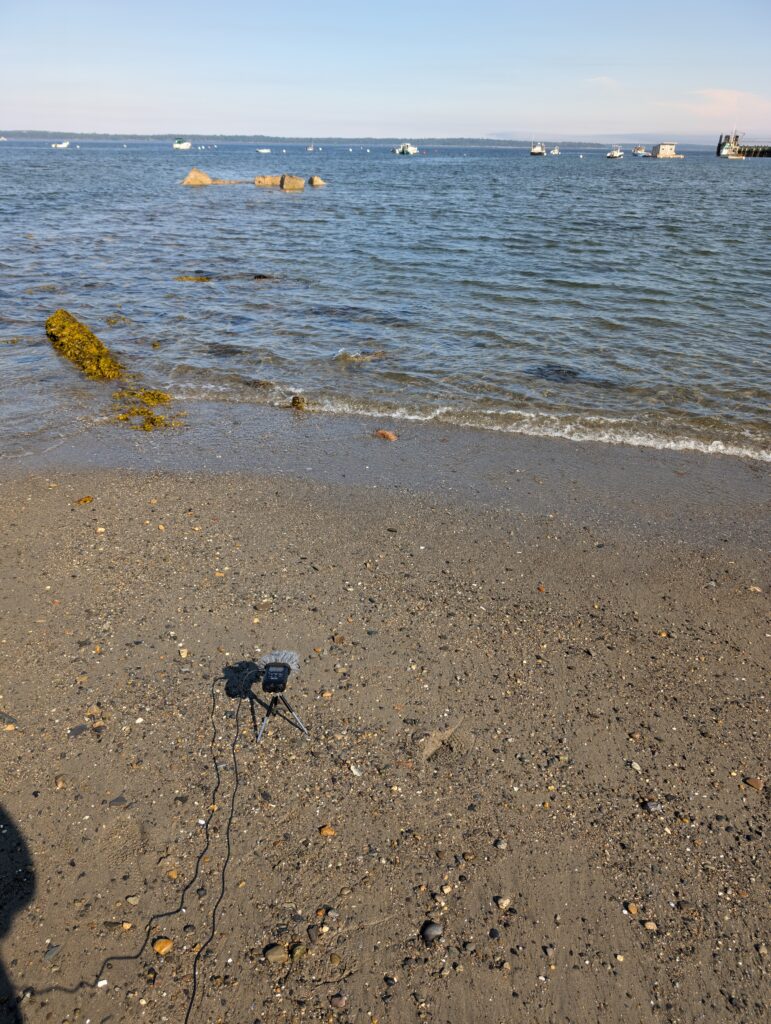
left=0, top=140, right=771, bottom=461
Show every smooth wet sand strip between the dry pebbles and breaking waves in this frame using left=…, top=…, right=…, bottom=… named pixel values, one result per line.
left=0, top=402, right=771, bottom=549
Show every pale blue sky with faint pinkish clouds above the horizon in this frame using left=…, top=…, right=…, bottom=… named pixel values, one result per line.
left=0, top=0, right=771, bottom=138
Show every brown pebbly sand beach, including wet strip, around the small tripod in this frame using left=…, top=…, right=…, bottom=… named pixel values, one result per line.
left=0, top=411, right=771, bottom=1024
